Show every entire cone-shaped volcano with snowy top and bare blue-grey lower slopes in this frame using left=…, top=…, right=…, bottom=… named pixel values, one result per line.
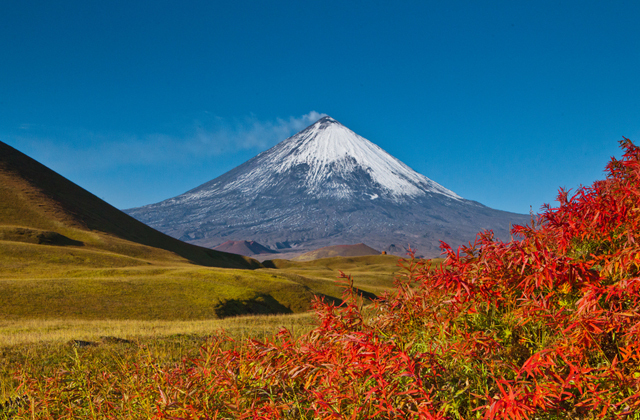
left=126, top=117, right=529, bottom=257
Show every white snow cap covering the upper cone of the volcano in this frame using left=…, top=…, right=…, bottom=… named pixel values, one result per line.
left=224, top=117, right=460, bottom=199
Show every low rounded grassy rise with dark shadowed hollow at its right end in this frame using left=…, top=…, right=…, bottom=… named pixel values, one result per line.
left=0, top=266, right=320, bottom=320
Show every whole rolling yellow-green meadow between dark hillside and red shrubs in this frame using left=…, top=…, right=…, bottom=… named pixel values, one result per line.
left=0, top=248, right=436, bottom=402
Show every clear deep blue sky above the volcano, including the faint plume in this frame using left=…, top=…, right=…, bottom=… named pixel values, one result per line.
left=0, top=0, right=640, bottom=213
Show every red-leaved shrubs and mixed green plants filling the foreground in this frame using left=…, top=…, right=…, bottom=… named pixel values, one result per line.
left=4, top=139, right=640, bottom=419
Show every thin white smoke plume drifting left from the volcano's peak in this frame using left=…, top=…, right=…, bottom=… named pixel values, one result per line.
left=7, top=111, right=326, bottom=171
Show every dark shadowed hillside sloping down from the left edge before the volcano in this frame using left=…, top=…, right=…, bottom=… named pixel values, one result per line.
left=0, top=142, right=260, bottom=269
